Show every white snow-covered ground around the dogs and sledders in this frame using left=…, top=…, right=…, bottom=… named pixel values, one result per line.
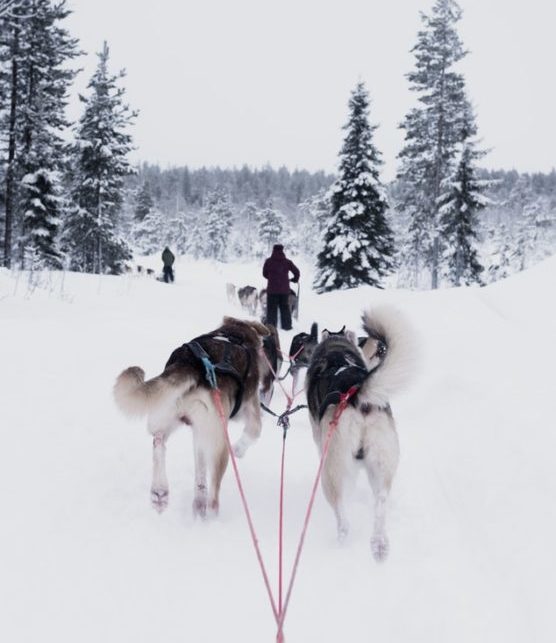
left=0, top=258, right=556, bottom=643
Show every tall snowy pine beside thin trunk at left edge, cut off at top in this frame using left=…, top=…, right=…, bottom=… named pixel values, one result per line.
left=18, top=0, right=79, bottom=267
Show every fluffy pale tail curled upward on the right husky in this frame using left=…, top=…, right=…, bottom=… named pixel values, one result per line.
left=362, top=305, right=418, bottom=401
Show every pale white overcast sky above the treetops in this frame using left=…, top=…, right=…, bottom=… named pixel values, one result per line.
left=66, top=0, right=556, bottom=180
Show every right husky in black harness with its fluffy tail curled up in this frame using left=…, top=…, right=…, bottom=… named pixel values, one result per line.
left=305, top=307, right=414, bottom=561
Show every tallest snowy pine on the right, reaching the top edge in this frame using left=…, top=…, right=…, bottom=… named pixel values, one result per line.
left=398, top=0, right=467, bottom=288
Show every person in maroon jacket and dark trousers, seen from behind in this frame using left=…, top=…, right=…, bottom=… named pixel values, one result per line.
left=263, top=244, right=299, bottom=330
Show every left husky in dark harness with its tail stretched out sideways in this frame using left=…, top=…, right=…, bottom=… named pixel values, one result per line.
left=114, top=317, right=269, bottom=518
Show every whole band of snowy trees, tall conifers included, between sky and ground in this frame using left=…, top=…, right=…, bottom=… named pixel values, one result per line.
left=0, top=0, right=556, bottom=292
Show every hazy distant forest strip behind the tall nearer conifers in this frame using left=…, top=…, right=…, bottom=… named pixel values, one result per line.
left=124, top=163, right=556, bottom=283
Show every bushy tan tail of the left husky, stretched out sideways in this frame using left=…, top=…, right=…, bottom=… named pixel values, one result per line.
left=114, top=366, right=195, bottom=417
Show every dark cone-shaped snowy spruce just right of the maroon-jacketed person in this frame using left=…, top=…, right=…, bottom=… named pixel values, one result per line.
left=314, top=82, right=394, bottom=293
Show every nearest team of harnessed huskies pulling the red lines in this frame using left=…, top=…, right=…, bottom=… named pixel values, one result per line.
left=114, top=300, right=413, bottom=561
